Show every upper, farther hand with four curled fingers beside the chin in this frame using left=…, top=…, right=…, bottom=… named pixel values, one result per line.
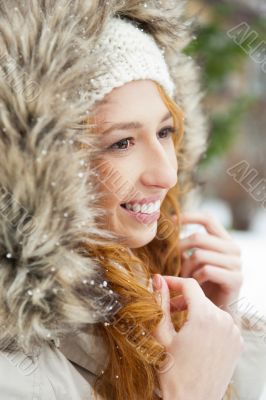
left=175, top=212, right=243, bottom=312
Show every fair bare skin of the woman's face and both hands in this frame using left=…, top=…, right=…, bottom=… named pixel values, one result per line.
left=93, top=80, right=243, bottom=400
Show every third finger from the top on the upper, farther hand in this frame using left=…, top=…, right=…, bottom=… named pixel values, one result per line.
left=180, top=250, right=241, bottom=278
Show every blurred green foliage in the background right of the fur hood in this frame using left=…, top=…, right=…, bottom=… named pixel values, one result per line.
left=182, top=3, right=266, bottom=165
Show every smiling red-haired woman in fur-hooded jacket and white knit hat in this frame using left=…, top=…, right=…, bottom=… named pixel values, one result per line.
left=0, top=0, right=266, bottom=400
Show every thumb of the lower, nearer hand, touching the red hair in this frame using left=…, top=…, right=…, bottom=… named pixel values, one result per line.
left=153, top=274, right=175, bottom=346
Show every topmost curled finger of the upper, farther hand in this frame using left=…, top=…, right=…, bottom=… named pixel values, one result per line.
left=180, top=212, right=232, bottom=240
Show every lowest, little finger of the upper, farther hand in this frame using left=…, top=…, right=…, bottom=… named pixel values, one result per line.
left=193, top=265, right=243, bottom=289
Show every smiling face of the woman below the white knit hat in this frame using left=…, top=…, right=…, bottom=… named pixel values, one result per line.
left=90, top=80, right=177, bottom=248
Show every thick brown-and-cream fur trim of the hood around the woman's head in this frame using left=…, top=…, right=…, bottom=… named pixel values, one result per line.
left=0, top=0, right=207, bottom=350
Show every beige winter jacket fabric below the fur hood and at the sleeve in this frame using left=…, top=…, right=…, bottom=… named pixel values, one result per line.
left=0, top=322, right=266, bottom=400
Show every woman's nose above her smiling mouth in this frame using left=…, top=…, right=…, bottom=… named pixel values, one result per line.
left=138, top=141, right=178, bottom=190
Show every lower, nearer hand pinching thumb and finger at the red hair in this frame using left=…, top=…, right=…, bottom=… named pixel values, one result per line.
left=154, top=275, right=244, bottom=400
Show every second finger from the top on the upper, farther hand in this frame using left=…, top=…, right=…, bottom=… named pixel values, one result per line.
left=179, top=232, right=240, bottom=256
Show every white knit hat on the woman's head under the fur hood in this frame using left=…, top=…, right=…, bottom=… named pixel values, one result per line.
left=83, top=17, right=175, bottom=110
